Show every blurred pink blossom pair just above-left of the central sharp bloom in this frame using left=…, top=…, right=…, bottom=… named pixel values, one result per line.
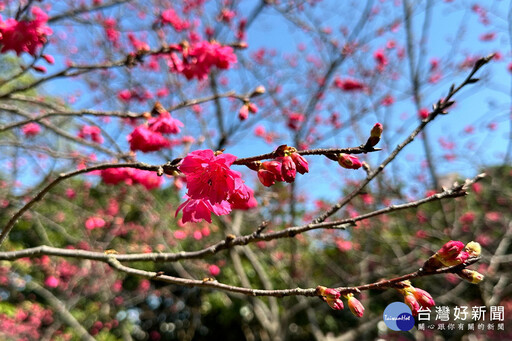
left=128, top=102, right=183, bottom=153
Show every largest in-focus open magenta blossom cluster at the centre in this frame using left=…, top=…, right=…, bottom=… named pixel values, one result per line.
left=176, top=149, right=257, bottom=223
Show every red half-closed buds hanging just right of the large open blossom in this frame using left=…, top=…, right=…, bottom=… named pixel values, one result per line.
left=250, top=145, right=309, bottom=187
